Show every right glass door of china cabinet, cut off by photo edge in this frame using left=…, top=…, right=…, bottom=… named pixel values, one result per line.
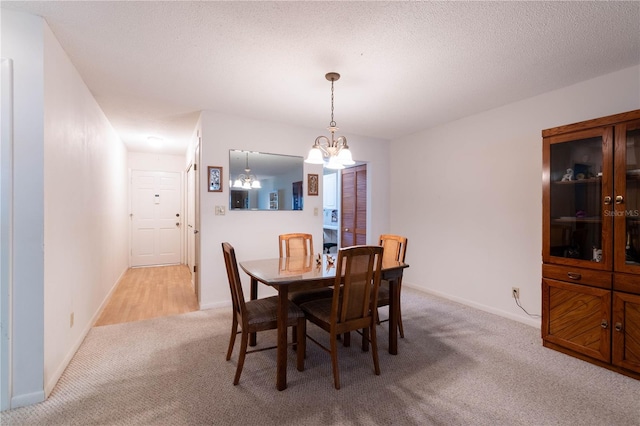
left=614, top=121, right=640, bottom=273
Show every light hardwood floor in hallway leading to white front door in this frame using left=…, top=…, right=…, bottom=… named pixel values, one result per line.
left=94, top=265, right=199, bottom=327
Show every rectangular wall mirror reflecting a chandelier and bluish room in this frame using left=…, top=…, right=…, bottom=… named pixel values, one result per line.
left=229, top=149, right=304, bottom=210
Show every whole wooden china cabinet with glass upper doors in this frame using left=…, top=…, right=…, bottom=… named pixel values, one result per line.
left=542, top=110, right=640, bottom=379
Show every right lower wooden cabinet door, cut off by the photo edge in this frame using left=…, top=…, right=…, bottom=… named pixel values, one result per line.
left=613, top=292, right=640, bottom=373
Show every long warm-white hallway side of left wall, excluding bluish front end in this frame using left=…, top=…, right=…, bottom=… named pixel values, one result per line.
left=40, top=25, right=129, bottom=394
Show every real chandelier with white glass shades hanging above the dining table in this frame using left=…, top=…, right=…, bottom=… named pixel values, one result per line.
left=304, top=72, right=355, bottom=169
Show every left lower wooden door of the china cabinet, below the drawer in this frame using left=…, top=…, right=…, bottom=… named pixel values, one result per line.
left=542, top=278, right=611, bottom=362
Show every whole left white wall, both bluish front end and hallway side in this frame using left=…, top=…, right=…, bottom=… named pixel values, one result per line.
left=2, top=9, right=127, bottom=408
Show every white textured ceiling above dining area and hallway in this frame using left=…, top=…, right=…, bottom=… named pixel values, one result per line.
left=2, top=0, right=640, bottom=154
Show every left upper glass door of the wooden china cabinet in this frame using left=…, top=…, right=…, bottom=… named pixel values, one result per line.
left=543, top=128, right=613, bottom=269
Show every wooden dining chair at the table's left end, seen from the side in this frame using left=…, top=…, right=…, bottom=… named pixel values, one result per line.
left=222, top=242, right=306, bottom=385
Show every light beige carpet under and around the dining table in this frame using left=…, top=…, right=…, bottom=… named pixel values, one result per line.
left=0, top=289, right=640, bottom=425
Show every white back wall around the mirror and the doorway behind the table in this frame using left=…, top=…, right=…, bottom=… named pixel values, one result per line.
left=200, top=111, right=389, bottom=309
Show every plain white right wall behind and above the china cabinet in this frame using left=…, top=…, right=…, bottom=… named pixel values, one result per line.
left=391, top=66, right=640, bottom=326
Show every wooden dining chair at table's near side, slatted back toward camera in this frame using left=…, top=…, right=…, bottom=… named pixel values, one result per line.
left=300, top=246, right=383, bottom=389
